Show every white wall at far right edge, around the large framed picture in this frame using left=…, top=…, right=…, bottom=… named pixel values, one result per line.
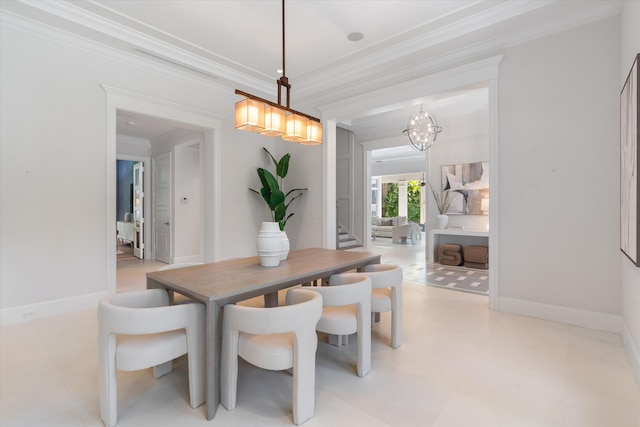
left=619, top=1, right=640, bottom=387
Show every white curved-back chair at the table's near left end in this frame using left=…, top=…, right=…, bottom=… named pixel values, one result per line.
left=98, top=289, right=205, bottom=427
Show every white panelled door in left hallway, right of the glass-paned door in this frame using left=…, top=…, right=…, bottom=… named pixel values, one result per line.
left=153, top=154, right=171, bottom=264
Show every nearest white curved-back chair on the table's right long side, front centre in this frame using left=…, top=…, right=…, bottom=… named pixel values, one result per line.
left=220, top=288, right=322, bottom=425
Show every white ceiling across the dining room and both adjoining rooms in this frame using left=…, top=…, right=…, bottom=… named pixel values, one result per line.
left=0, top=0, right=620, bottom=145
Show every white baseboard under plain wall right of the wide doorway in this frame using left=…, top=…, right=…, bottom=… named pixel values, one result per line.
left=498, top=297, right=624, bottom=334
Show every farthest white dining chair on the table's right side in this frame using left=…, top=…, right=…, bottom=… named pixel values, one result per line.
left=358, top=264, right=403, bottom=348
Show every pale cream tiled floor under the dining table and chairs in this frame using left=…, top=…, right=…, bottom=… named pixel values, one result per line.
left=0, top=240, right=640, bottom=427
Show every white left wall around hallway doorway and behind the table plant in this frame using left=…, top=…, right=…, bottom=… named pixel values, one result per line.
left=0, top=18, right=322, bottom=324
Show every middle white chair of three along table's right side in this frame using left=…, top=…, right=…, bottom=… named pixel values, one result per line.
left=309, top=273, right=371, bottom=377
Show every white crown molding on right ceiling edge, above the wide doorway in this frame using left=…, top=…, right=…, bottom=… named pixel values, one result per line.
left=296, top=0, right=621, bottom=104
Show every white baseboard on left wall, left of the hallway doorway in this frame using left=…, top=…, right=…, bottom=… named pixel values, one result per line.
left=0, top=291, right=107, bottom=326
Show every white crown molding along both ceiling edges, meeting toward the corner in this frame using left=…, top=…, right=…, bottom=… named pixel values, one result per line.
left=1, top=0, right=621, bottom=111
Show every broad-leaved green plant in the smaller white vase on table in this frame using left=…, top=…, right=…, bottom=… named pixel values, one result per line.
left=249, top=147, right=307, bottom=260
